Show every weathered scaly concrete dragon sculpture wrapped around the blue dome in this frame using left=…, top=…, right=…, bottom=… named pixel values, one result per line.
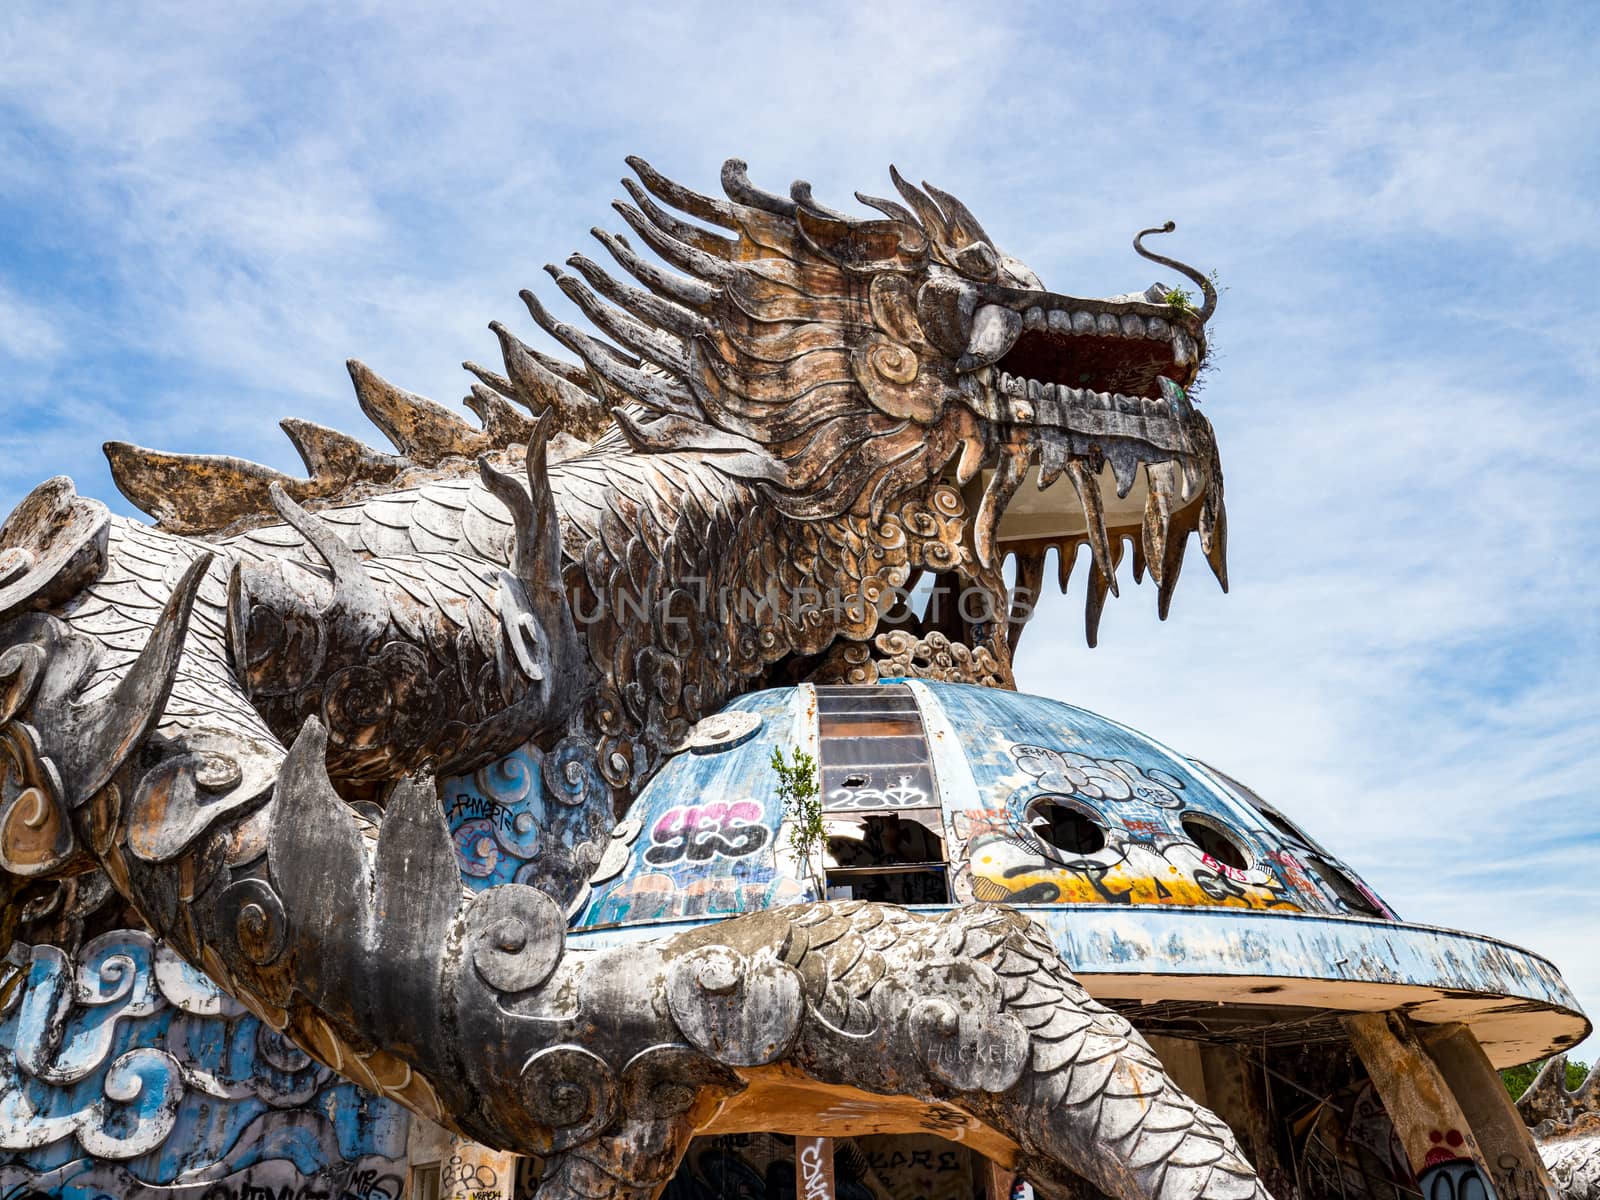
left=0, top=158, right=1266, bottom=1200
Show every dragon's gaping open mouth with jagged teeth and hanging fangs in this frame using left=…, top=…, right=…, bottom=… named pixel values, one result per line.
left=952, top=267, right=1221, bottom=662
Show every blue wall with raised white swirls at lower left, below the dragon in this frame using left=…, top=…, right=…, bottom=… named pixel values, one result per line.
left=0, top=928, right=408, bottom=1200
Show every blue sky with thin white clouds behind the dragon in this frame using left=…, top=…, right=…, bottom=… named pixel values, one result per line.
left=0, top=2, right=1600, bottom=1056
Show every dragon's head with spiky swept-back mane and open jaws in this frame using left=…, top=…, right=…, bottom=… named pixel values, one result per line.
left=524, top=158, right=1227, bottom=659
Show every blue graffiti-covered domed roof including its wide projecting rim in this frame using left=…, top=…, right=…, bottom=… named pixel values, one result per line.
left=553, top=680, right=1589, bottom=1064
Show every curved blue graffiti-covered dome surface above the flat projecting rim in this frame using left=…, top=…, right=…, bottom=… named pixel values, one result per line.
left=578, top=683, right=1394, bottom=928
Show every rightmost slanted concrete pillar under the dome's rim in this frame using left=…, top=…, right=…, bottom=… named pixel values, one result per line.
left=1418, top=1024, right=1560, bottom=1200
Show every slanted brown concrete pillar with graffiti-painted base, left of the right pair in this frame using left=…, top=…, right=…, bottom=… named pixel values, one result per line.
left=1344, top=1013, right=1509, bottom=1200
